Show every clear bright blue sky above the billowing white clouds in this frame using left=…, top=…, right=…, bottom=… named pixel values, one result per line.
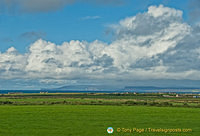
left=0, top=0, right=189, bottom=53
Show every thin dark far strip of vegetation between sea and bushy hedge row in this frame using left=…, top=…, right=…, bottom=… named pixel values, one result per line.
left=0, top=93, right=197, bottom=99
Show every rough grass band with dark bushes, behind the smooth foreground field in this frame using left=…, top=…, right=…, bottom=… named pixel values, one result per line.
left=0, top=93, right=200, bottom=108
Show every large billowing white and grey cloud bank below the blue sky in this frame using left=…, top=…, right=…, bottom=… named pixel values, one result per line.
left=0, top=5, right=200, bottom=81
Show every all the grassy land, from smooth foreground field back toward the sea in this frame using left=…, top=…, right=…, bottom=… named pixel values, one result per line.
left=0, top=94, right=200, bottom=136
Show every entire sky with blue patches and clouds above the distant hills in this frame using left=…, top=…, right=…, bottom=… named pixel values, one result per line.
left=0, top=0, right=200, bottom=90
